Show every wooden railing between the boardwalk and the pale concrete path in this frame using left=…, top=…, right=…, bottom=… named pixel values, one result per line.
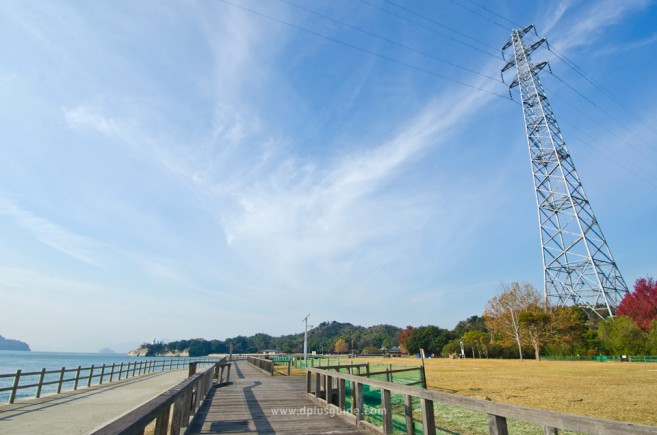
left=92, top=357, right=230, bottom=435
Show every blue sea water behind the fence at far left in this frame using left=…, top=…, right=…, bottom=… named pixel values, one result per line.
left=0, top=350, right=205, bottom=405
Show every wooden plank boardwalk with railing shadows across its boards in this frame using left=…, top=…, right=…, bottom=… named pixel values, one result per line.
left=187, top=361, right=370, bottom=434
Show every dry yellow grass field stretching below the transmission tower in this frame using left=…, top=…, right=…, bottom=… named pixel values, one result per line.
left=352, top=358, right=657, bottom=426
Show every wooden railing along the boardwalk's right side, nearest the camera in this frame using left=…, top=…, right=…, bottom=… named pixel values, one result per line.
left=306, top=368, right=657, bottom=435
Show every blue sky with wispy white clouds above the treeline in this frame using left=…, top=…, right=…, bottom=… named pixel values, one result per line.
left=0, top=0, right=657, bottom=351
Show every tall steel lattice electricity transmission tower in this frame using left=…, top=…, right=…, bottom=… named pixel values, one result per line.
left=502, top=24, right=628, bottom=317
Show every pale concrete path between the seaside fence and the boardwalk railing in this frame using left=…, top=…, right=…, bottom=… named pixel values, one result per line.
left=0, top=369, right=188, bottom=435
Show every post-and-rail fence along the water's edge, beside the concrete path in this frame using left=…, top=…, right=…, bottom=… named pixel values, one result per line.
left=0, top=358, right=220, bottom=403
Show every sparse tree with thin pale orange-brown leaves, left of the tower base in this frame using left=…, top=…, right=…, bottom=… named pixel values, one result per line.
left=484, top=282, right=542, bottom=360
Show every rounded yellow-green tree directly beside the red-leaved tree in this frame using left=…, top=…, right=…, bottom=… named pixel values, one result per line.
left=598, top=316, right=646, bottom=355
